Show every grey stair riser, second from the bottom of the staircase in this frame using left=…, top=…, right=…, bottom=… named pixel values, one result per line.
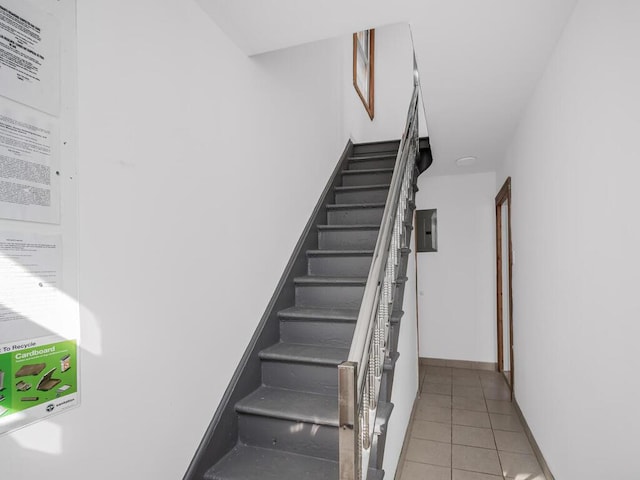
left=262, top=360, right=338, bottom=395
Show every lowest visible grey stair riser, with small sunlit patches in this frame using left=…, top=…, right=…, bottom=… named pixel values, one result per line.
left=238, top=414, right=338, bottom=460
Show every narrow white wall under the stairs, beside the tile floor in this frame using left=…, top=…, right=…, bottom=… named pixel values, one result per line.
left=382, top=217, right=418, bottom=478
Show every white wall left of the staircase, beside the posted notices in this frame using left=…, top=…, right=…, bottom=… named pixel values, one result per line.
left=0, top=0, right=347, bottom=480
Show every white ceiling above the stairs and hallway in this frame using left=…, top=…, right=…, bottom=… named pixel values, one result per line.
left=197, top=0, right=576, bottom=175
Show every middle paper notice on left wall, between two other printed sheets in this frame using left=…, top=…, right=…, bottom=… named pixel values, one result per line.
left=0, top=98, right=60, bottom=223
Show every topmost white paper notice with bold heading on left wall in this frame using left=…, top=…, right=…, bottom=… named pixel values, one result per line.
left=0, top=0, right=60, bottom=115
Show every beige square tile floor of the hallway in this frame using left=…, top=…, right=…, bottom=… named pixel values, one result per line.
left=400, top=366, right=545, bottom=480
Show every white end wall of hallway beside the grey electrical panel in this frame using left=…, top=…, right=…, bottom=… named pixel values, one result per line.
left=416, top=170, right=497, bottom=362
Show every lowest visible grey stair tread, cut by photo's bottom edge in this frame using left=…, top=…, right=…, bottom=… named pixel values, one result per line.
left=204, top=445, right=384, bottom=480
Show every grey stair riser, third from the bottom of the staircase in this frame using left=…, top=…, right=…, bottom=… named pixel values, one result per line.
left=280, top=321, right=356, bottom=348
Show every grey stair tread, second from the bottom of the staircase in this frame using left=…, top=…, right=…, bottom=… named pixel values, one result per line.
left=236, top=384, right=338, bottom=427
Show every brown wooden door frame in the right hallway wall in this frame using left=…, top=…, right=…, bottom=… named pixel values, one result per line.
left=496, top=177, right=515, bottom=399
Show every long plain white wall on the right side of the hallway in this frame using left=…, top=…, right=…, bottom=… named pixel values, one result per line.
left=498, top=1, right=640, bottom=480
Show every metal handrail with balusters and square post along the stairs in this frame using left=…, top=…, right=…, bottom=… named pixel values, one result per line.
left=338, top=78, right=419, bottom=480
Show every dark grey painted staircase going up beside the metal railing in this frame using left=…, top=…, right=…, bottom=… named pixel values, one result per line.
left=185, top=141, right=428, bottom=480
